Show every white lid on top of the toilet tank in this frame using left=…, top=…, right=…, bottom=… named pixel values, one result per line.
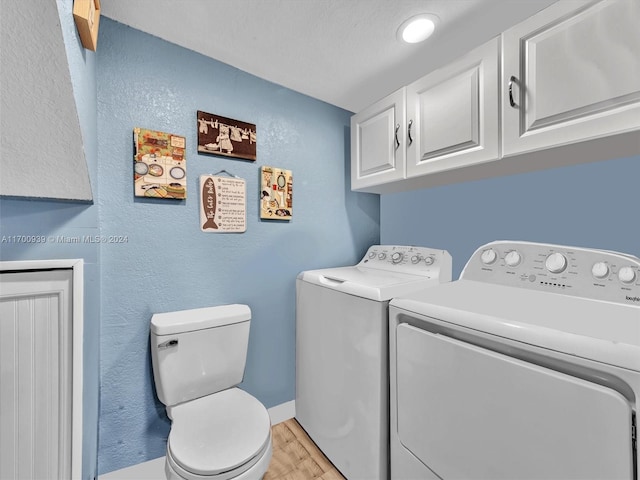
left=151, top=304, right=251, bottom=335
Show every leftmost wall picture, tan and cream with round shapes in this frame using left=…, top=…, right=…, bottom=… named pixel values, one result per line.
left=133, top=127, right=187, bottom=200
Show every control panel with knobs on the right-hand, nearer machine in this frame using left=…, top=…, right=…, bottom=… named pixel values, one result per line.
left=460, top=241, right=640, bottom=306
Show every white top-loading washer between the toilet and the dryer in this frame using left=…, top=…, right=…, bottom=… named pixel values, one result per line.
left=295, top=245, right=451, bottom=480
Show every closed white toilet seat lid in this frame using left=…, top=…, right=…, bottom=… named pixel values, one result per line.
left=168, top=388, right=271, bottom=475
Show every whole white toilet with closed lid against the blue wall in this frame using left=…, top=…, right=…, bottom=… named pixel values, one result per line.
left=151, top=305, right=272, bottom=480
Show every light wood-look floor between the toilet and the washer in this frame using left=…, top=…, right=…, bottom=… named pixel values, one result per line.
left=263, top=418, right=345, bottom=480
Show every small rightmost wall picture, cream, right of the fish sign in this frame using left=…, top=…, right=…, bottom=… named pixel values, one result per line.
left=260, top=166, right=293, bottom=220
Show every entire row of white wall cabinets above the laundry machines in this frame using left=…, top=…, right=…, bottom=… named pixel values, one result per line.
left=351, top=0, right=640, bottom=193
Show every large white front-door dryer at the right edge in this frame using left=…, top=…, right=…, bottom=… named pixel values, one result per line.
left=389, top=241, right=640, bottom=480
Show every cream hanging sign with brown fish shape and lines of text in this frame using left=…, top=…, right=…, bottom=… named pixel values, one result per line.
left=200, top=175, right=247, bottom=233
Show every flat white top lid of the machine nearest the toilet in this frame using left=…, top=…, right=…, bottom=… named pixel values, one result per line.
left=298, top=266, right=440, bottom=301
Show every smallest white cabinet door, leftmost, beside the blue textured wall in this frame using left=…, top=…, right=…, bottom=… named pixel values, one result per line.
left=351, top=88, right=405, bottom=190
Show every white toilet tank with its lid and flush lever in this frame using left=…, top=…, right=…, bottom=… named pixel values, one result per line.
left=151, top=304, right=251, bottom=407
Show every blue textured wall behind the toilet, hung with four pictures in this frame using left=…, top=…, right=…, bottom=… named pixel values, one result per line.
left=92, top=19, right=379, bottom=473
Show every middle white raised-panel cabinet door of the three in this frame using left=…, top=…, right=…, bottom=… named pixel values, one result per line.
left=407, top=38, right=500, bottom=177
